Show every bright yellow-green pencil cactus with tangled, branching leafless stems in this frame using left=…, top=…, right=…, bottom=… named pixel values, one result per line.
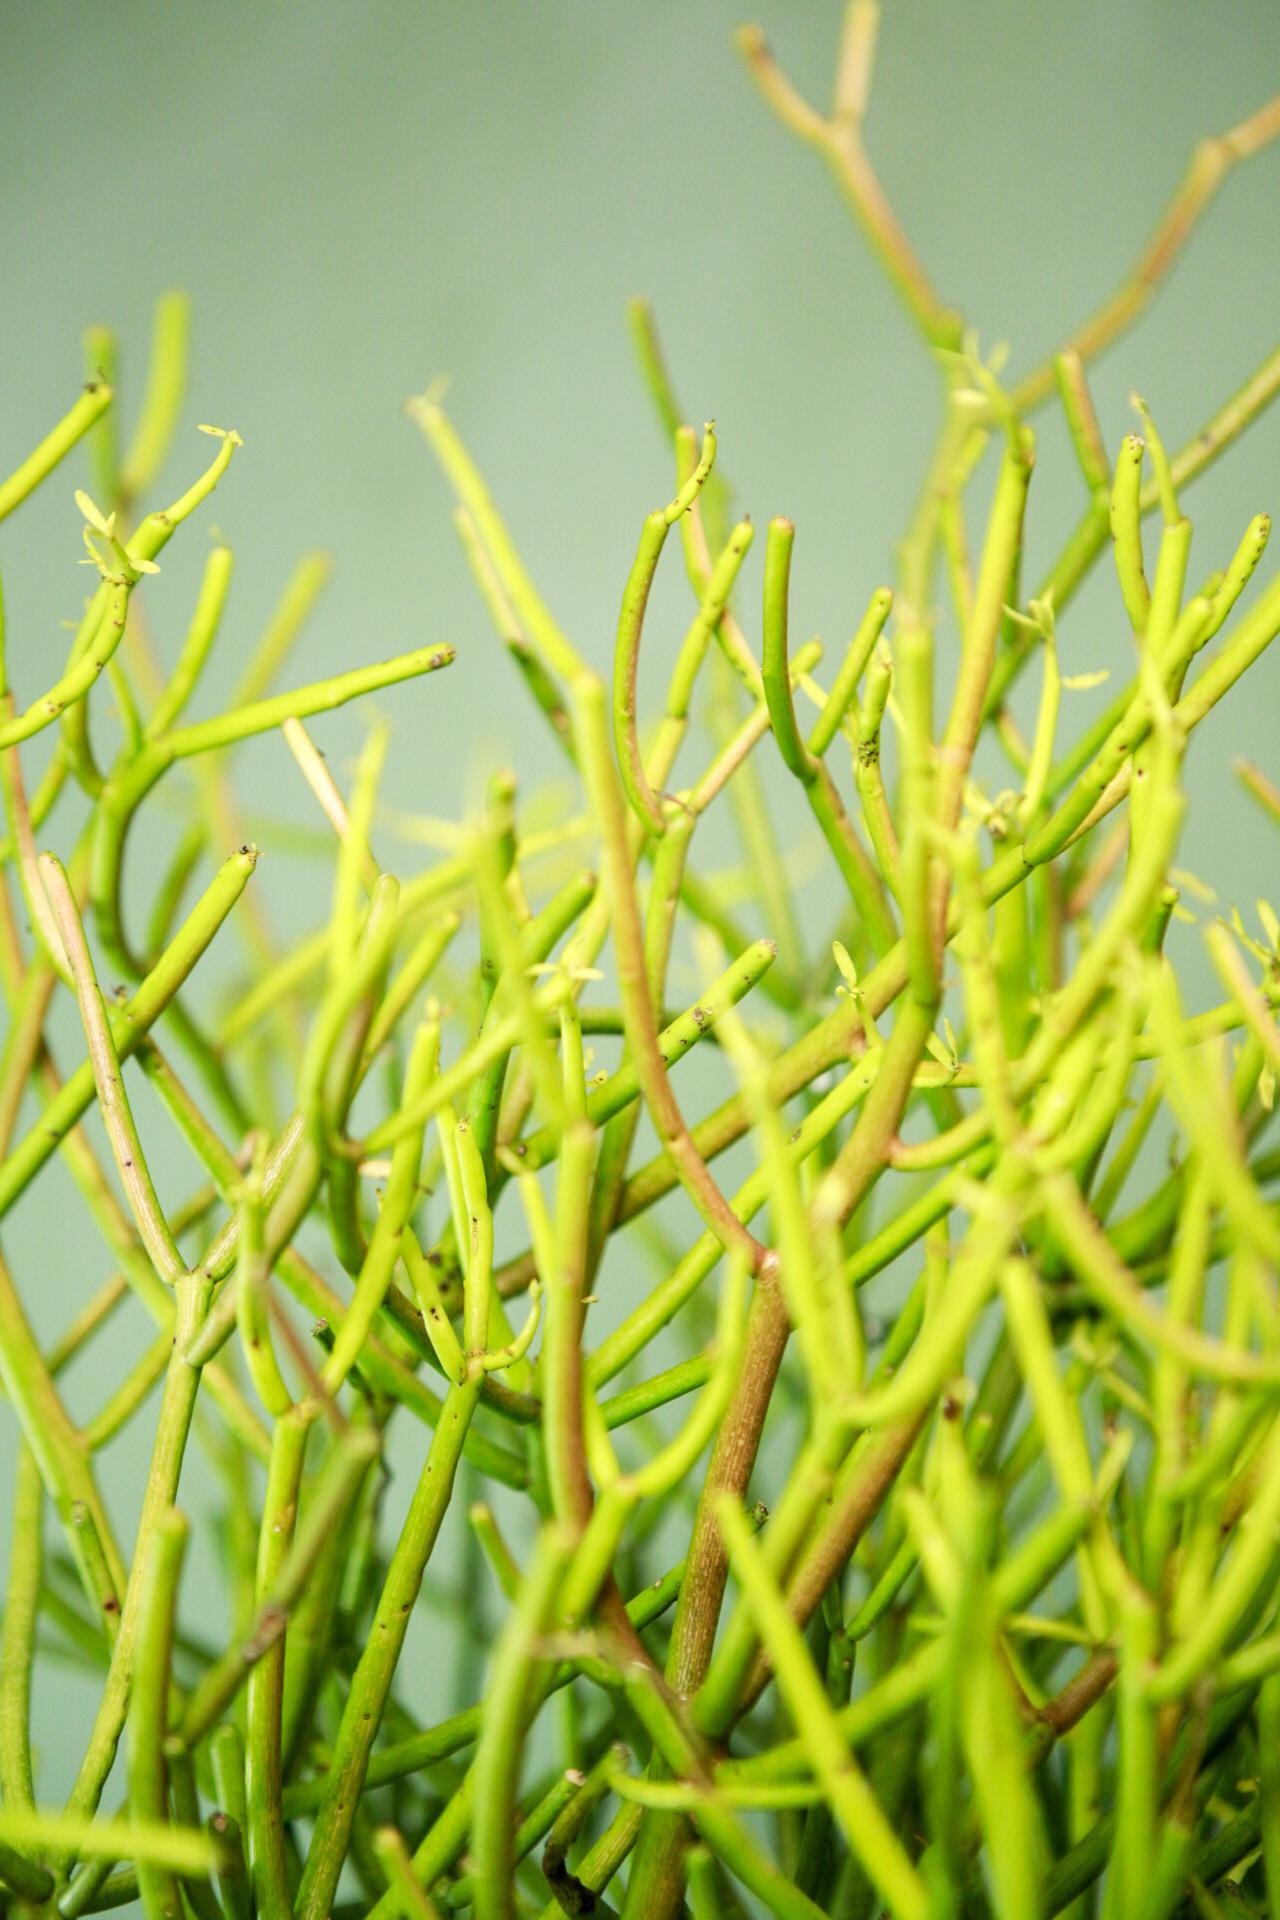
left=0, top=0, right=1280, bottom=1920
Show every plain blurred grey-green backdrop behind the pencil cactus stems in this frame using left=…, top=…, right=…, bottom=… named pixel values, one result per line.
left=0, top=0, right=1280, bottom=1795
